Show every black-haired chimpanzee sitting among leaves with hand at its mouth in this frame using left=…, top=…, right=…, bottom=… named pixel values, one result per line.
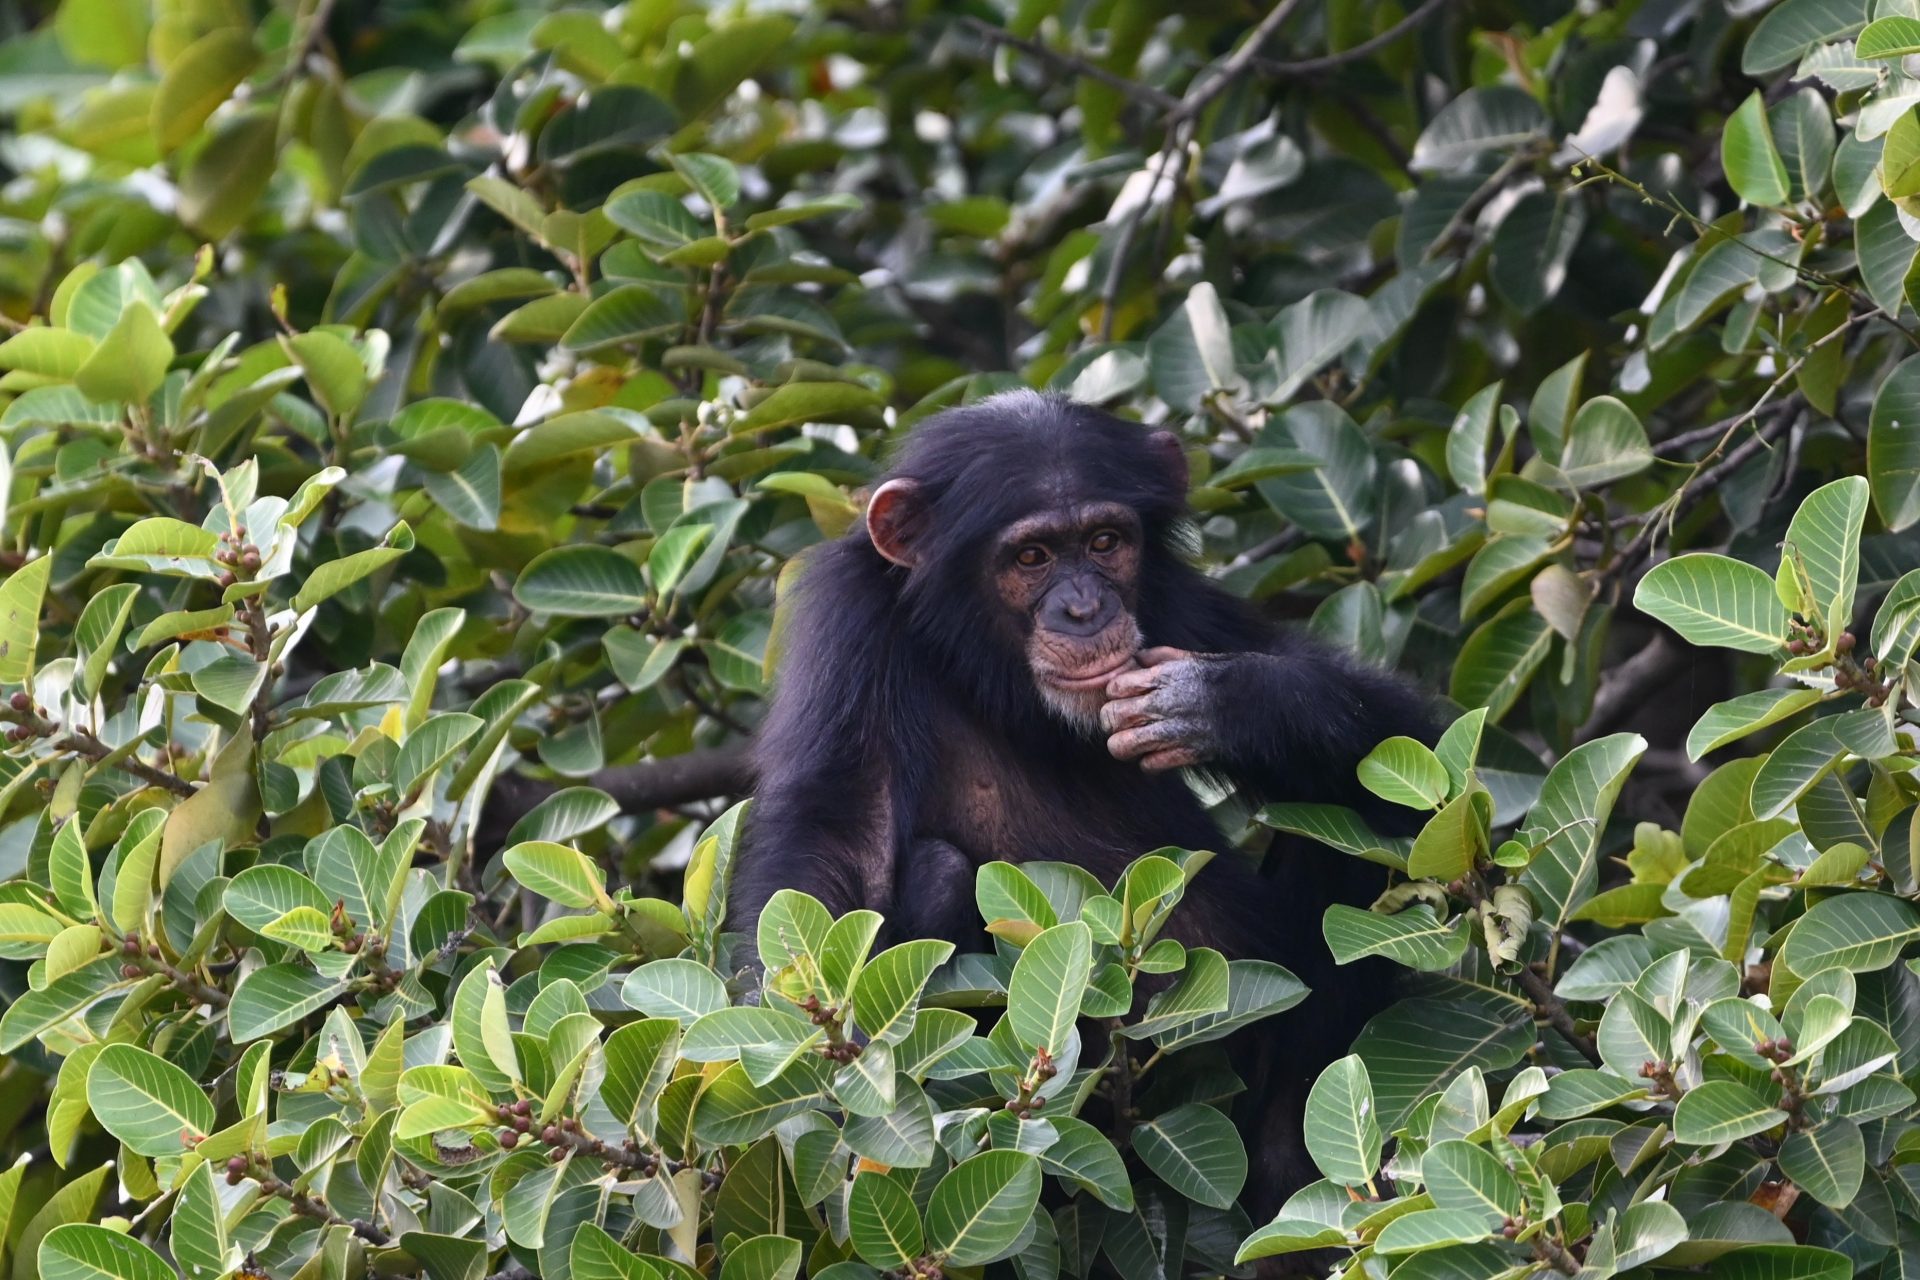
left=730, top=391, right=1432, bottom=1221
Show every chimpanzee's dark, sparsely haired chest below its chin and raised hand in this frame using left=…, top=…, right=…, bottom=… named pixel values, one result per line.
left=912, top=727, right=1219, bottom=867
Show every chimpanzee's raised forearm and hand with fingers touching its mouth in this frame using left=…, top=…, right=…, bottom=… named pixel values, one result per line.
left=1102, top=635, right=1432, bottom=821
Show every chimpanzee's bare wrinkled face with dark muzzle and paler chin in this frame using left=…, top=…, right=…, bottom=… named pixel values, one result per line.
left=991, top=503, right=1140, bottom=733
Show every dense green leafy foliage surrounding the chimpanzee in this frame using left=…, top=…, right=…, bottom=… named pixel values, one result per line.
left=0, top=0, right=1920, bottom=1280
